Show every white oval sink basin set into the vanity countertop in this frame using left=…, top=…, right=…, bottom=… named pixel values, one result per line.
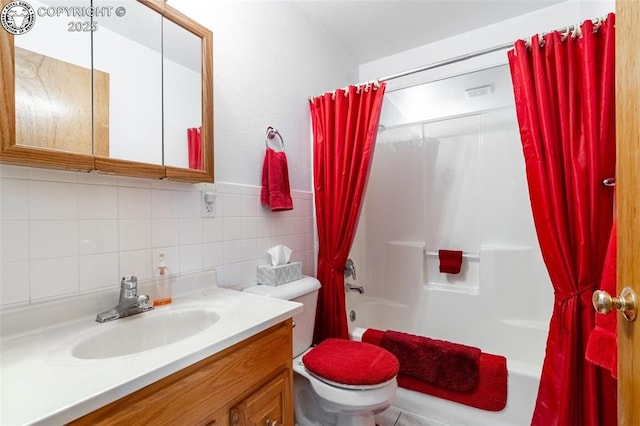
left=71, top=308, right=220, bottom=359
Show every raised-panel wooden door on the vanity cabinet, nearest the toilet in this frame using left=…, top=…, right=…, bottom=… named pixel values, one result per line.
left=230, top=371, right=289, bottom=426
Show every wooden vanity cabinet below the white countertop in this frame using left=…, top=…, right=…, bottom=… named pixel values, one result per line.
left=70, top=319, right=293, bottom=426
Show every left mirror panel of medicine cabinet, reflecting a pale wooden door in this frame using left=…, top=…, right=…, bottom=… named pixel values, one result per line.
left=11, top=2, right=93, bottom=155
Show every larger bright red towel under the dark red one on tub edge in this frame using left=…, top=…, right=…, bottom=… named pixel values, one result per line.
left=362, top=328, right=508, bottom=411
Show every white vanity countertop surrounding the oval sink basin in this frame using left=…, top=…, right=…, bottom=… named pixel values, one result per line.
left=0, top=287, right=302, bottom=426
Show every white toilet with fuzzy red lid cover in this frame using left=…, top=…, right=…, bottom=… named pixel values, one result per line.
left=244, top=276, right=398, bottom=426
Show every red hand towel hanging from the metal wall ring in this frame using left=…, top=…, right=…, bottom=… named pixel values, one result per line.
left=260, top=148, right=293, bottom=211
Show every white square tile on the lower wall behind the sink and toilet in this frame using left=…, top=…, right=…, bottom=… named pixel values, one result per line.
left=0, top=165, right=314, bottom=309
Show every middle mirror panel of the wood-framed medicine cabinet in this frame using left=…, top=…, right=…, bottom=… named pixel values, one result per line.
left=93, top=0, right=164, bottom=164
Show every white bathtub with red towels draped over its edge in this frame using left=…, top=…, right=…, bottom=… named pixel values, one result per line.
left=347, top=293, right=546, bottom=426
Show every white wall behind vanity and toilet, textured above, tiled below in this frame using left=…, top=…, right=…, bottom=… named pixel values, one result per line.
left=0, top=0, right=357, bottom=309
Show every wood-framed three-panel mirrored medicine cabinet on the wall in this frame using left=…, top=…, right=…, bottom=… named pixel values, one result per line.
left=0, top=0, right=213, bottom=182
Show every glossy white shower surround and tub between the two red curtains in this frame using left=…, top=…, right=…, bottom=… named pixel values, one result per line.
left=347, top=79, right=553, bottom=426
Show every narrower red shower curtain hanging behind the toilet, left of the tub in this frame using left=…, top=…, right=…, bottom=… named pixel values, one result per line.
left=310, top=83, right=385, bottom=343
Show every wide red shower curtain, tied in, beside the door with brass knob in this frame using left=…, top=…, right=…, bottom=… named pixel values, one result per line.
left=508, top=14, right=616, bottom=426
